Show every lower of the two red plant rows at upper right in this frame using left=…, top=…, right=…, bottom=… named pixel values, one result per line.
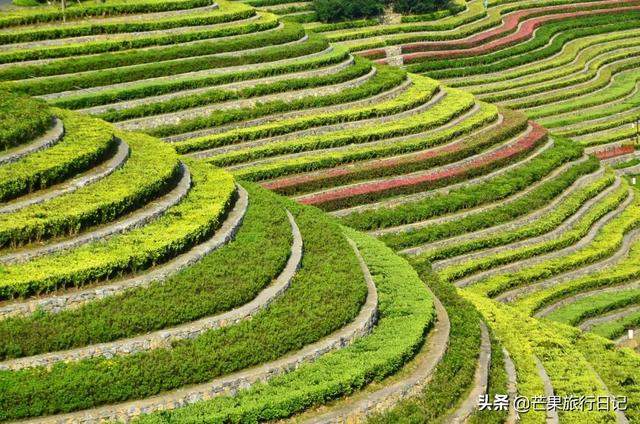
left=403, top=2, right=640, bottom=64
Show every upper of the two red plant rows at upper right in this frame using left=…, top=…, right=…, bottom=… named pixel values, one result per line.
left=402, top=0, right=637, bottom=53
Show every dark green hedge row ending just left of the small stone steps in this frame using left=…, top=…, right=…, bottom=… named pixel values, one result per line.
left=97, top=58, right=371, bottom=122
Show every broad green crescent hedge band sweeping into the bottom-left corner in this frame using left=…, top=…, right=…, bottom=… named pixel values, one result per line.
left=0, top=192, right=367, bottom=420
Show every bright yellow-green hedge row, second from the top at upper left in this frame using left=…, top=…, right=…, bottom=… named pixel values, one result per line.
left=0, top=6, right=255, bottom=44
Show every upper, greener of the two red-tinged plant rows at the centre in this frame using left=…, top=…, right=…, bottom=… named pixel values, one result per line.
left=262, top=110, right=527, bottom=196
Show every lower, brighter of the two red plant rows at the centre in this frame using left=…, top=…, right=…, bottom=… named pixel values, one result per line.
left=298, top=122, right=547, bottom=210
